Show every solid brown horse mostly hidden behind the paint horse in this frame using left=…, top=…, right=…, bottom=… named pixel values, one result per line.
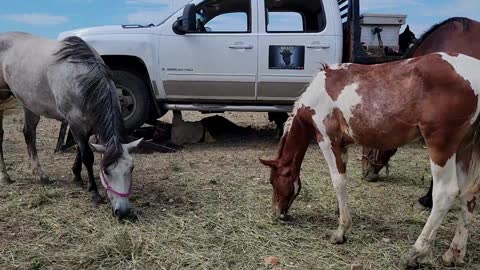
left=362, top=17, right=480, bottom=208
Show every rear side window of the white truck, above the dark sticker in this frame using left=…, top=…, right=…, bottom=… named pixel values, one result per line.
left=265, top=0, right=326, bottom=33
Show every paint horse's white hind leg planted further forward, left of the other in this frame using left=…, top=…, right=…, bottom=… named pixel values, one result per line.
left=400, top=155, right=459, bottom=268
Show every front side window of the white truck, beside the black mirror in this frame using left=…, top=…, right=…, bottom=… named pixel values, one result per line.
left=196, top=0, right=251, bottom=33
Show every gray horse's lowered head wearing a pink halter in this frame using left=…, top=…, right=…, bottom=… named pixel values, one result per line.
left=92, top=139, right=142, bottom=219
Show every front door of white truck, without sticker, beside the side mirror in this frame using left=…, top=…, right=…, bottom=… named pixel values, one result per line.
left=159, top=0, right=258, bottom=102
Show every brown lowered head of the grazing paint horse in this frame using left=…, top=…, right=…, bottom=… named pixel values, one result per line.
left=260, top=136, right=302, bottom=220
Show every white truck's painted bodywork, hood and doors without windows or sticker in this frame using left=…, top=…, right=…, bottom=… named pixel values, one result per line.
left=58, top=0, right=343, bottom=104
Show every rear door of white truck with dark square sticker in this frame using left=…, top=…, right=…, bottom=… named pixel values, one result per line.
left=257, top=0, right=342, bottom=103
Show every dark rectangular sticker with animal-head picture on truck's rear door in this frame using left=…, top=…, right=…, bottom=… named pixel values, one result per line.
left=268, top=45, right=305, bottom=70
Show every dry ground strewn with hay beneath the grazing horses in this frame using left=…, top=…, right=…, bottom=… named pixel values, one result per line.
left=0, top=110, right=480, bottom=270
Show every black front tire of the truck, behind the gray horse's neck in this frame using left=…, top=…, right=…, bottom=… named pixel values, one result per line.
left=112, top=70, right=151, bottom=130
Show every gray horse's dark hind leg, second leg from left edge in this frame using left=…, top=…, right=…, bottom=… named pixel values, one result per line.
left=23, top=108, right=50, bottom=184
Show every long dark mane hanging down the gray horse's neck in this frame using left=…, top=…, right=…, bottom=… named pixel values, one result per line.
left=55, top=36, right=125, bottom=168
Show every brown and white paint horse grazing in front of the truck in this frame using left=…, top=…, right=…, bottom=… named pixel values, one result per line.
left=261, top=53, right=480, bottom=267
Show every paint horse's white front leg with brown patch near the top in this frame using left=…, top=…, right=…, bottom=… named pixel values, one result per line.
left=319, top=140, right=352, bottom=244
